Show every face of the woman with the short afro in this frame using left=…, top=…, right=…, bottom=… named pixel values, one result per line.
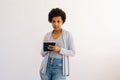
left=51, top=16, right=63, bottom=30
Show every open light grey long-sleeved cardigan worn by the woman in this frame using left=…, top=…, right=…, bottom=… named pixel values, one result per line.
left=40, top=29, right=75, bottom=76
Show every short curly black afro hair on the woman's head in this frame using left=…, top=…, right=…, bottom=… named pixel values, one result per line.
left=48, top=8, right=66, bottom=23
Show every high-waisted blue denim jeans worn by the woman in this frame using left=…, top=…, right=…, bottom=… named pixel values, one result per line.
left=40, top=57, right=66, bottom=80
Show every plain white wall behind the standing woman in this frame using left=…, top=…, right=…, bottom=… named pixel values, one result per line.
left=0, top=0, right=120, bottom=80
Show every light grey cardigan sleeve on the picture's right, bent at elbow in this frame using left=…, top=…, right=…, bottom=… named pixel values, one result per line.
left=59, top=32, right=75, bottom=56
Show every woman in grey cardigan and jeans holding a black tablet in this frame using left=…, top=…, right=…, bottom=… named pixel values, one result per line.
left=40, top=8, right=75, bottom=80
